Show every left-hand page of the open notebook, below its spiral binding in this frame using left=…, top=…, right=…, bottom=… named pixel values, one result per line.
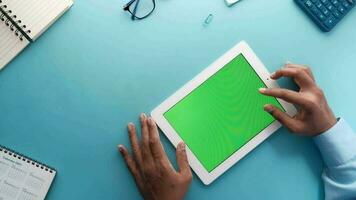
left=0, top=17, right=29, bottom=70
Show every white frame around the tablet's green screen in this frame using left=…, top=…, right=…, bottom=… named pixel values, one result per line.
left=151, top=41, right=297, bottom=185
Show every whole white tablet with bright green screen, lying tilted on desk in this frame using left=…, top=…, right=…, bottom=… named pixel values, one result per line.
left=151, top=42, right=296, bottom=185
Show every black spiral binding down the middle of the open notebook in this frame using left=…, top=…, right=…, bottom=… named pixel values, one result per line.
left=0, top=0, right=31, bottom=41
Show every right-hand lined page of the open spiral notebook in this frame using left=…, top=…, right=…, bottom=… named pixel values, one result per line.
left=2, top=0, right=73, bottom=40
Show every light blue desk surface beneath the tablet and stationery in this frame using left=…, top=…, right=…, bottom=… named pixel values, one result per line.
left=0, top=0, right=356, bottom=200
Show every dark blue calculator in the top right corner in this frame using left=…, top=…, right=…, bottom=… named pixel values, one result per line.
left=295, top=0, right=356, bottom=32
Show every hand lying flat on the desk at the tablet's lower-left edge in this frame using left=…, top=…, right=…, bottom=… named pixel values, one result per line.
left=118, top=114, right=192, bottom=200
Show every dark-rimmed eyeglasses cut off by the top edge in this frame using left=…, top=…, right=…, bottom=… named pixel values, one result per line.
left=124, top=0, right=156, bottom=20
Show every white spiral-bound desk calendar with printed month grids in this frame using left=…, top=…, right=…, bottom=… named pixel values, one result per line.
left=0, top=145, right=56, bottom=200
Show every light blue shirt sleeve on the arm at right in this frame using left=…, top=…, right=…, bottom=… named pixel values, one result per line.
left=314, top=119, right=356, bottom=200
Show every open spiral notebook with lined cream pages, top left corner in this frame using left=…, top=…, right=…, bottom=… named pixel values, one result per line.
left=0, top=0, right=73, bottom=70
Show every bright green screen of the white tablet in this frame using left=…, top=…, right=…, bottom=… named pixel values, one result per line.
left=163, top=54, right=284, bottom=172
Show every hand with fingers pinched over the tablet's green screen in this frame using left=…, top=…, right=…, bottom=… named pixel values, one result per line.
left=260, top=64, right=337, bottom=136
